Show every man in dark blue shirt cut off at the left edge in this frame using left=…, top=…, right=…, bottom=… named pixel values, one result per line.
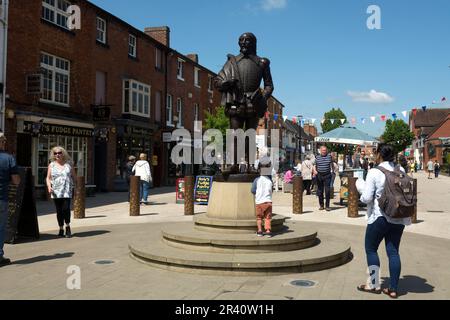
left=0, top=132, right=20, bottom=267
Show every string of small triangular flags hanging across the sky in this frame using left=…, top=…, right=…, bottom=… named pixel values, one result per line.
left=265, top=97, right=447, bottom=126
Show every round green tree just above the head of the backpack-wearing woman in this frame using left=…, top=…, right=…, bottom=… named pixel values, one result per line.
left=381, top=120, right=414, bottom=154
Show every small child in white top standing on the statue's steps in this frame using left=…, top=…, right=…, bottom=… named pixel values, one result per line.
left=252, top=157, right=273, bottom=238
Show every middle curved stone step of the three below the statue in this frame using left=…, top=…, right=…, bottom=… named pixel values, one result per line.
left=162, top=223, right=319, bottom=253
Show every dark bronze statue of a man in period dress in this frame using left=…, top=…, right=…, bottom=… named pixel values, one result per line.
left=214, top=33, right=274, bottom=173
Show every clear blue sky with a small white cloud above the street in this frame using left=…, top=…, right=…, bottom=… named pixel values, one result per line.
left=92, top=0, right=450, bottom=136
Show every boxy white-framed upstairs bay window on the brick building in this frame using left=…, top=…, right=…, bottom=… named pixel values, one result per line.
left=122, top=79, right=152, bottom=118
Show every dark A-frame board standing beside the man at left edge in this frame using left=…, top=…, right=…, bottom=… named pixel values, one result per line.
left=5, top=168, right=39, bottom=244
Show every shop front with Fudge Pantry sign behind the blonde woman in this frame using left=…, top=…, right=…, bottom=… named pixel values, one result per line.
left=17, top=116, right=94, bottom=198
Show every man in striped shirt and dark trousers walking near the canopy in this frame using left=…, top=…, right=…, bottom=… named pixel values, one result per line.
left=313, top=146, right=333, bottom=211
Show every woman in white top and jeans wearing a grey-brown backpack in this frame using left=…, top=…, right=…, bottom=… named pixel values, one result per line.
left=357, top=144, right=416, bottom=299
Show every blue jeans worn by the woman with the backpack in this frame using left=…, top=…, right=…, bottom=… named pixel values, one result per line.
left=366, top=217, right=405, bottom=291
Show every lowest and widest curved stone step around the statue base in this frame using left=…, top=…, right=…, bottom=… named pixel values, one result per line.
left=129, top=225, right=351, bottom=275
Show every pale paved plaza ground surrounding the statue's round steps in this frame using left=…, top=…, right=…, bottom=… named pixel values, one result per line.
left=0, top=173, right=450, bottom=300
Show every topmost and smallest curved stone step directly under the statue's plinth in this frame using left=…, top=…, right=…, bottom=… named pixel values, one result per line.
left=194, top=214, right=286, bottom=234
